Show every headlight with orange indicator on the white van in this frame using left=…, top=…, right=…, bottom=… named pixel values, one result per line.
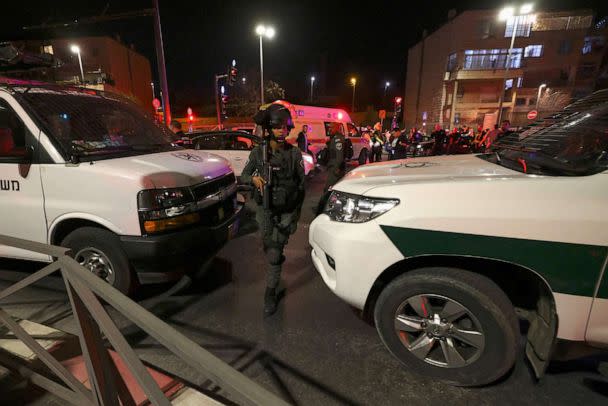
left=137, top=188, right=200, bottom=234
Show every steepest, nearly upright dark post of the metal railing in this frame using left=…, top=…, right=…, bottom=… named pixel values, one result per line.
left=61, top=276, right=119, bottom=406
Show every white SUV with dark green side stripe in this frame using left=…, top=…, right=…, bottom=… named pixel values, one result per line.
left=309, top=90, right=608, bottom=385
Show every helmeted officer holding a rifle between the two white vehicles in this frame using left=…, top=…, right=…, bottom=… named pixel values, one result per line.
left=241, top=104, right=305, bottom=316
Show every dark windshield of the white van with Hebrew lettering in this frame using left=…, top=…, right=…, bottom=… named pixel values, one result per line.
left=15, top=87, right=174, bottom=160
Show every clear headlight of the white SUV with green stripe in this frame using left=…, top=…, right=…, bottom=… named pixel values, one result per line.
left=323, top=191, right=399, bottom=223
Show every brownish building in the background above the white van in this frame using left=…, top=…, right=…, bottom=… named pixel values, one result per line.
left=2, top=37, right=153, bottom=109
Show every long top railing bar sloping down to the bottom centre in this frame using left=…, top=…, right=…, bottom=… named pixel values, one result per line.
left=59, top=256, right=288, bottom=406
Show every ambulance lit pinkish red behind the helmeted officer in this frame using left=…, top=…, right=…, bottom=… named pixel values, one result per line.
left=274, top=100, right=370, bottom=165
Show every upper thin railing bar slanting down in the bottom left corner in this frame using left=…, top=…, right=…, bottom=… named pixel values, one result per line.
left=0, top=309, right=92, bottom=400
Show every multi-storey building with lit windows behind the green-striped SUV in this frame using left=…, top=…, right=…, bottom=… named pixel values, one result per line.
left=404, top=10, right=608, bottom=128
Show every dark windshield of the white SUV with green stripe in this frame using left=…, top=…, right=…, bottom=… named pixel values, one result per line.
left=482, top=97, right=608, bottom=176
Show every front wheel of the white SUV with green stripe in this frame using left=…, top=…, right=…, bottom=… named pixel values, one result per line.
left=374, top=268, right=519, bottom=386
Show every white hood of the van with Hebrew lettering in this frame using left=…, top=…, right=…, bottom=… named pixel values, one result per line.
left=88, top=150, right=232, bottom=189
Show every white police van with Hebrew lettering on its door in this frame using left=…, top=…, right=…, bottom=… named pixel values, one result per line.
left=0, top=79, right=238, bottom=293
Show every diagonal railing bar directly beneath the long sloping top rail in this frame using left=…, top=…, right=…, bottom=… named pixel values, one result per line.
left=68, top=274, right=171, bottom=406
